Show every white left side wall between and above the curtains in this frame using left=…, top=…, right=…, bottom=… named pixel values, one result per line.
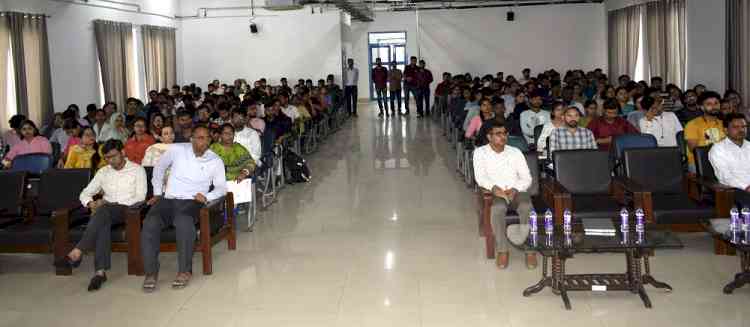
left=4, top=0, right=179, bottom=111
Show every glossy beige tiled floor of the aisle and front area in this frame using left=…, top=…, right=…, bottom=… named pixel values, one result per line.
left=0, top=105, right=750, bottom=327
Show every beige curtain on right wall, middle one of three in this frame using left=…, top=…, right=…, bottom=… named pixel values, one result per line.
left=643, top=0, right=686, bottom=87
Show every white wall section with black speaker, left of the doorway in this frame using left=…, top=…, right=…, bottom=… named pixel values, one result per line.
left=179, top=0, right=341, bottom=85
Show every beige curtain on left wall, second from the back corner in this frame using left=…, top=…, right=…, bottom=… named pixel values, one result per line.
left=94, top=20, right=138, bottom=110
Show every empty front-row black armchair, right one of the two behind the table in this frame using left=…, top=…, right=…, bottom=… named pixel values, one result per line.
left=624, top=148, right=717, bottom=231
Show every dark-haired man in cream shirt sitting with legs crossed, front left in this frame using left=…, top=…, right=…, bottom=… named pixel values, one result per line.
left=55, top=140, right=147, bottom=292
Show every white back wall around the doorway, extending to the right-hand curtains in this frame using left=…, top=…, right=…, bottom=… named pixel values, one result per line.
left=346, top=4, right=607, bottom=97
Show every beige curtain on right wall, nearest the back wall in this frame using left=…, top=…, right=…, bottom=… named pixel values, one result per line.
left=608, top=6, right=641, bottom=83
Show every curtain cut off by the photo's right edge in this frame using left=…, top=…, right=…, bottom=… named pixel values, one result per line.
left=726, top=0, right=750, bottom=107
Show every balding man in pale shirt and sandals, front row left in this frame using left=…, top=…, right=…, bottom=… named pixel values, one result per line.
left=141, top=126, right=227, bottom=292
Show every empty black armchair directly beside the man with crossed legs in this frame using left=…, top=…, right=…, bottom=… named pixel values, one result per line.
left=0, top=169, right=91, bottom=275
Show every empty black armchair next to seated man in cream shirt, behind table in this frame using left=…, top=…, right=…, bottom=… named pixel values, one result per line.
left=542, top=150, right=624, bottom=224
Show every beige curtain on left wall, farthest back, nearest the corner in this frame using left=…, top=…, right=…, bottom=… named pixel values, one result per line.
left=141, top=25, right=177, bottom=91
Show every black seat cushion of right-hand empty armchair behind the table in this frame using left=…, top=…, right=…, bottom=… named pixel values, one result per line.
left=652, top=194, right=715, bottom=225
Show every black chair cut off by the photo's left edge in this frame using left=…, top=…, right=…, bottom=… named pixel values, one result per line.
left=0, top=171, right=26, bottom=228
